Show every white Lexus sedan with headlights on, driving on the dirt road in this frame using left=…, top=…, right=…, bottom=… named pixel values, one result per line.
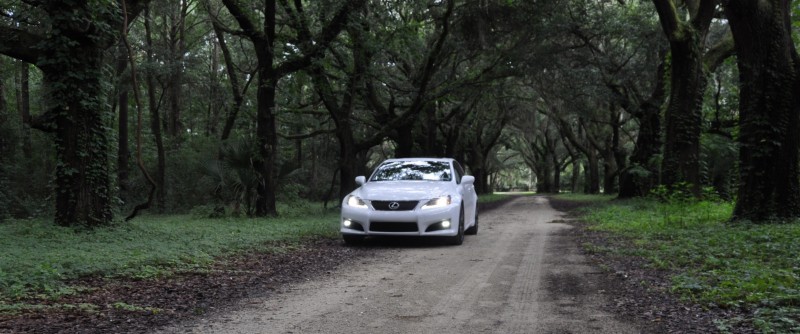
left=340, top=158, right=478, bottom=245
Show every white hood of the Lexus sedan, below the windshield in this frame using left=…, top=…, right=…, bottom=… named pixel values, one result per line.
left=354, top=181, right=455, bottom=201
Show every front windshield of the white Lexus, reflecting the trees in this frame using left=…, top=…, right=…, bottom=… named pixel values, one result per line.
left=370, top=160, right=452, bottom=181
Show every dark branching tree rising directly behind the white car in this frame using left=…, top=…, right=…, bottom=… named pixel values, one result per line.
left=311, top=1, right=455, bottom=199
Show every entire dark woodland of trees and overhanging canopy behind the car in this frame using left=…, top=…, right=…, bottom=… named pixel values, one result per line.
left=0, top=0, right=800, bottom=227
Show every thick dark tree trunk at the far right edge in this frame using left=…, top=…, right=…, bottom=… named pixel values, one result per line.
left=725, top=0, right=800, bottom=222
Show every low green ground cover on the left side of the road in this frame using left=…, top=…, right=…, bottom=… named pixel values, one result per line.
left=0, top=205, right=339, bottom=304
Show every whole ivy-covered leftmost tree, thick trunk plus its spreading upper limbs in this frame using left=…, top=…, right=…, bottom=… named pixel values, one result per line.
left=0, top=0, right=147, bottom=227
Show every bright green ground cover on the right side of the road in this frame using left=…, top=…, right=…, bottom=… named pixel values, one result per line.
left=583, top=199, right=800, bottom=333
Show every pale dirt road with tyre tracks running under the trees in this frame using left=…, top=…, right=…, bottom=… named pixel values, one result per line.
left=155, top=197, right=642, bottom=334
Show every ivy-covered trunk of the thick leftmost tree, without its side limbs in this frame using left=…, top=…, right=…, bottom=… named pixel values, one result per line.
left=38, top=2, right=131, bottom=227
